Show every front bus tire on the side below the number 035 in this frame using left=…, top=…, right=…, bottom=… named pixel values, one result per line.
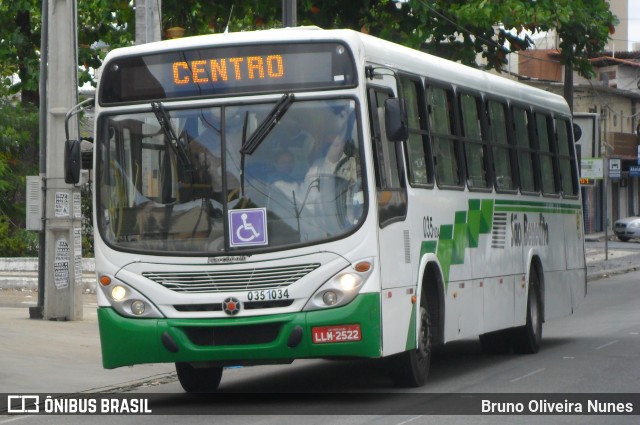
left=390, top=291, right=433, bottom=388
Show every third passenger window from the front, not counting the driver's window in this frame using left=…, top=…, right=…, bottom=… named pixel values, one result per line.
left=459, top=93, right=489, bottom=190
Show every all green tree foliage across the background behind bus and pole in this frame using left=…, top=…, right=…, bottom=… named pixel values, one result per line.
left=0, top=0, right=617, bottom=255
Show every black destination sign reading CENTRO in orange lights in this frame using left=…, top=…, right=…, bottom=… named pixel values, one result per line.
left=99, top=42, right=356, bottom=105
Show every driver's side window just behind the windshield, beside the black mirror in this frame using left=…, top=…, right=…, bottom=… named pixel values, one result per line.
left=369, top=88, right=407, bottom=227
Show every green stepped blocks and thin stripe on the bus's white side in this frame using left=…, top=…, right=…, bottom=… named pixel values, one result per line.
left=420, top=199, right=581, bottom=290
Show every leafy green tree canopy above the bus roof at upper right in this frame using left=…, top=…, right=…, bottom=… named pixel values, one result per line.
left=365, top=0, right=618, bottom=78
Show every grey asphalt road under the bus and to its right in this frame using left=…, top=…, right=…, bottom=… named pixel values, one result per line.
left=139, top=266, right=640, bottom=396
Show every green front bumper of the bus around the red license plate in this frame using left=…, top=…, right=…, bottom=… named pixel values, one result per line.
left=98, top=294, right=381, bottom=369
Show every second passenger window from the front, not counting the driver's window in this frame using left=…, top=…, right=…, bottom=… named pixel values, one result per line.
left=427, top=86, right=462, bottom=186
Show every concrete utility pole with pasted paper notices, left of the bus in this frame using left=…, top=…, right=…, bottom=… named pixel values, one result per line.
left=40, top=0, right=83, bottom=320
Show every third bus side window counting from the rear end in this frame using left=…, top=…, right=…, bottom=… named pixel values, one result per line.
left=513, top=107, right=538, bottom=193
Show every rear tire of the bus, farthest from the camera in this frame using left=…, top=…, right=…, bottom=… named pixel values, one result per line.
left=513, top=267, right=542, bottom=354
